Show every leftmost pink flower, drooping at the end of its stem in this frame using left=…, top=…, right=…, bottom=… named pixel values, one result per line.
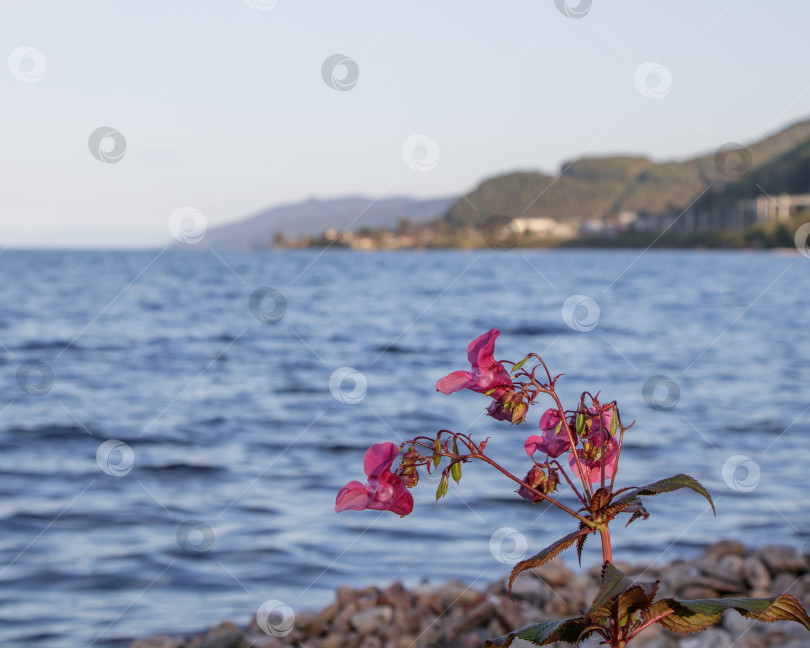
left=335, top=443, right=413, bottom=515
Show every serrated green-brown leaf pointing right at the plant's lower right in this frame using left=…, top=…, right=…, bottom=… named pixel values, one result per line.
left=648, top=594, right=810, bottom=634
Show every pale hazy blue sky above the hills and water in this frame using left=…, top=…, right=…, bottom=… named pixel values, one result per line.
left=0, top=0, right=810, bottom=246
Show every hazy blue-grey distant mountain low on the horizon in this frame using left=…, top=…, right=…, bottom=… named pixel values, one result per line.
left=196, top=196, right=455, bottom=250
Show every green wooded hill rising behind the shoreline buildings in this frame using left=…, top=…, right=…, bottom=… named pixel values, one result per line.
left=443, top=120, right=810, bottom=227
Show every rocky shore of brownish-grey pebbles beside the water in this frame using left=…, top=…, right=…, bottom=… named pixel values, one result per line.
left=132, top=540, right=810, bottom=648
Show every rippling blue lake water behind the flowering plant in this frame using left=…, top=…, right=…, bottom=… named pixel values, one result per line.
left=0, top=250, right=810, bottom=647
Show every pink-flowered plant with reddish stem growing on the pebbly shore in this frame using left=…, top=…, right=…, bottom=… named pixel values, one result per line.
left=335, top=329, right=810, bottom=648
